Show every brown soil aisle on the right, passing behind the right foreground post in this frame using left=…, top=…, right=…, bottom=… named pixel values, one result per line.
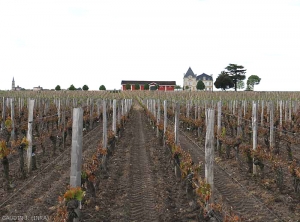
left=180, top=128, right=300, bottom=222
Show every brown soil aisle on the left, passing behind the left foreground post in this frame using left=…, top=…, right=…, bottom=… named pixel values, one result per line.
left=0, top=120, right=102, bottom=221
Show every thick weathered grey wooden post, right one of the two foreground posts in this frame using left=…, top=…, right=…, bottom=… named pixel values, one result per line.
left=205, top=109, right=215, bottom=211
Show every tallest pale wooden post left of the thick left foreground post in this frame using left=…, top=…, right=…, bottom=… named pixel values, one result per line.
left=27, top=99, right=34, bottom=173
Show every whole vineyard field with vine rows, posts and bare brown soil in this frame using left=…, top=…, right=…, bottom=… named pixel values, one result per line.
left=0, top=91, right=300, bottom=222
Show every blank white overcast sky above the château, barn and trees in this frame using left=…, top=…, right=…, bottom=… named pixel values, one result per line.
left=0, top=0, right=300, bottom=91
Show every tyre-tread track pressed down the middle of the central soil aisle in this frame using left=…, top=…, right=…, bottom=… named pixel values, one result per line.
left=129, top=109, right=158, bottom=221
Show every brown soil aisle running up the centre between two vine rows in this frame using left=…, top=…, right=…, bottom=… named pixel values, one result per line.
left=82, top=106, right=199, bottom=222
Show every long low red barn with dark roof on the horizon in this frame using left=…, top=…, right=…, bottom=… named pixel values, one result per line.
left=121, top=80, right=176, bottom=91
